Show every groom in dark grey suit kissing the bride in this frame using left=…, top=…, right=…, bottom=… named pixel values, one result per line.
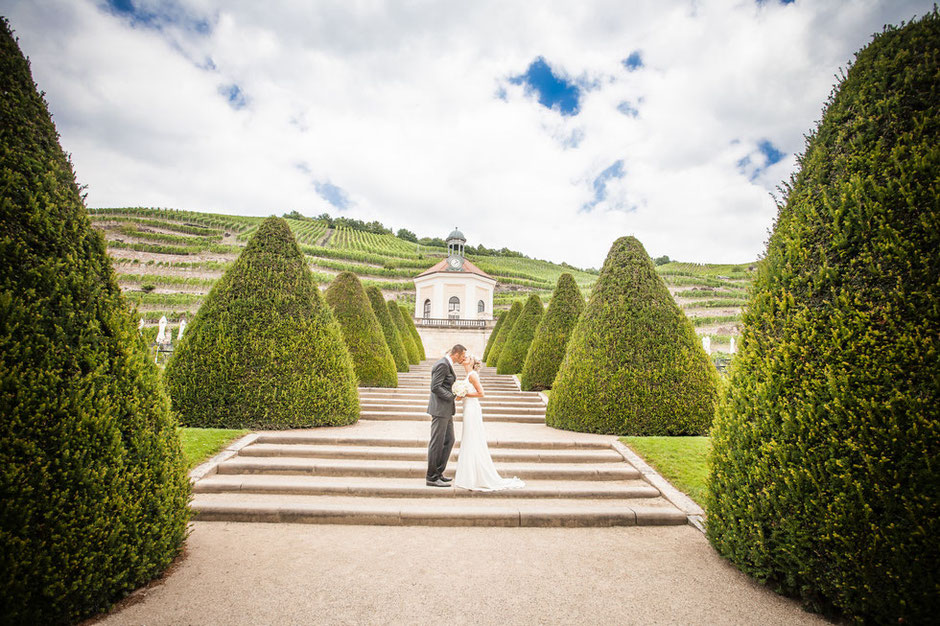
left=426, top=343, right=467, bottom=487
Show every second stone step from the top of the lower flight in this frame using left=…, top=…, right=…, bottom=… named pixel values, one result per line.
left=238, top=443, right=624, bottom=463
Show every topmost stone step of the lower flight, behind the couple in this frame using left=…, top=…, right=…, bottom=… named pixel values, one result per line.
left=255, top=431, right=611, bottom=452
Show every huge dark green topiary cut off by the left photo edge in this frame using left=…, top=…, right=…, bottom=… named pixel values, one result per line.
left=0, top=20, right=189, bottom=624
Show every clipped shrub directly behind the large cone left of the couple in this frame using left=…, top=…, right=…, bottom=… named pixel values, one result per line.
left=324, top=272, right=398, bottom=387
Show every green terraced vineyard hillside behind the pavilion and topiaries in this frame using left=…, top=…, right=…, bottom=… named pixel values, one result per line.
left=90, top=208, right=753, bottom=350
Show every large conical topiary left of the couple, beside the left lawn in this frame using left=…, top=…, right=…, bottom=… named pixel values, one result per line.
left=164, top=217, right=359, bottom=428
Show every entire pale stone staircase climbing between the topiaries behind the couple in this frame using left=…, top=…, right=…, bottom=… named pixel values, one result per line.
left=191, top=361, right=687, bottom=526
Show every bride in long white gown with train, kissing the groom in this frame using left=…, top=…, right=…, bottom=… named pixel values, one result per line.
left=454, top=355, right=525, bottom=491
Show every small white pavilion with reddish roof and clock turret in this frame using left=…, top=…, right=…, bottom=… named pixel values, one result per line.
left=414, top=228, right=496, bottom=320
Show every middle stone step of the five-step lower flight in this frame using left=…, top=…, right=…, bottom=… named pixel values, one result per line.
left=217, top=454, right=640, bottom=480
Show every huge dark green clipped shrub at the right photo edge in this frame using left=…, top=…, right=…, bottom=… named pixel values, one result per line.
left=707, top=10, right=940, bottom=624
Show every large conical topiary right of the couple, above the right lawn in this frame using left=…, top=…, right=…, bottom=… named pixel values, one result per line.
left=546, top=237, right=718, bottom=435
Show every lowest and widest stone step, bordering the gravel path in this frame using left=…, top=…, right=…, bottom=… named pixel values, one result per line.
left=191, top=493, right=686, bottom=526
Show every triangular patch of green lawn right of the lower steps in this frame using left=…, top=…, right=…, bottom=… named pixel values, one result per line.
left=620, top=437, right=712, bottom=508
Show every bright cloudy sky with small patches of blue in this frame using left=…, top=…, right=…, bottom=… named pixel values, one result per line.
left=0, top=0, right=933, bottom=267
